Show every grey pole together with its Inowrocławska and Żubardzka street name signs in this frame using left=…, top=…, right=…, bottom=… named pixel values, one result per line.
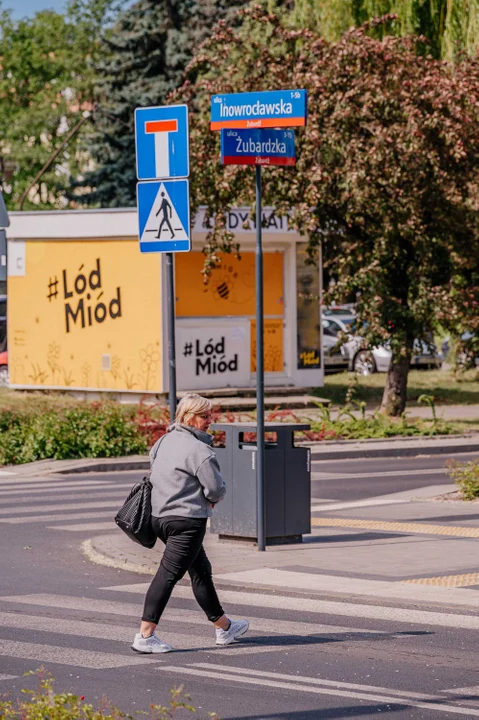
left=210, top=90, right=308, bottom=551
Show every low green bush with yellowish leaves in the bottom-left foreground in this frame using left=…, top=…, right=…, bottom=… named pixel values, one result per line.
left=0, top=668, right=219, bottom=720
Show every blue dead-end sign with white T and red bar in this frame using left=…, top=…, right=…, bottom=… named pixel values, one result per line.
left=135, top=105, right=190, bottom=180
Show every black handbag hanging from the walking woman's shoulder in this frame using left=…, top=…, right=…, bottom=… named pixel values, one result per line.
left=115, top=436, right=164, bottom=549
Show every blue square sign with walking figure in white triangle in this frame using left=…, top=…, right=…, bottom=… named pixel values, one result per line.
left=137, top=180, right=191, bottom=253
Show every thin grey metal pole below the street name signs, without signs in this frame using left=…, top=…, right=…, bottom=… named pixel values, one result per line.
left=256, top=165, right=266, bottom=552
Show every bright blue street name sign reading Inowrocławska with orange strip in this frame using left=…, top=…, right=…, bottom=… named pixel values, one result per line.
left=210, top=90, right=308, bottom=130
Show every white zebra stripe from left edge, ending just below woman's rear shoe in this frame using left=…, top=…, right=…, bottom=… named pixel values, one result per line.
left=0, top=639, right=163, bottom=670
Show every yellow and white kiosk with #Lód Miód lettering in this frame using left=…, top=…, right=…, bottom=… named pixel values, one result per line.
left=8, top=208, right=323, bottom=396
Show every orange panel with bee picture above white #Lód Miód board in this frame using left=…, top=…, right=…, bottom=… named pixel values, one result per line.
left=175, top=252, right=283, bottom=317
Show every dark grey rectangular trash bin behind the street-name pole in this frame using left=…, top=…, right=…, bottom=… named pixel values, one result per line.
left=211, top=423, right=311, bottom=545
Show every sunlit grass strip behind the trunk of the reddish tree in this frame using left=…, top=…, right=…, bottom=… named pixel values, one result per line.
left=313, top=370, right=479, bottom=405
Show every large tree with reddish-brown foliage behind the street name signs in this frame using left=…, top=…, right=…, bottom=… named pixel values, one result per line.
left=171, top=7, right=479, bottom=415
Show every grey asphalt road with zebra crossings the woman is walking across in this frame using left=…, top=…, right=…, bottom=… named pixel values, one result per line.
left=0, top=458, right=479, bottom=720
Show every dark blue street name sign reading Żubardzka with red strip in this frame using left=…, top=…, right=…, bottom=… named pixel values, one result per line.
left=221, top=128, right=296, bottom=165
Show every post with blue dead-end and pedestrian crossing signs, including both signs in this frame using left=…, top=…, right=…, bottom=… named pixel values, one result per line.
left=135, top=105, right=191, bottom=422
